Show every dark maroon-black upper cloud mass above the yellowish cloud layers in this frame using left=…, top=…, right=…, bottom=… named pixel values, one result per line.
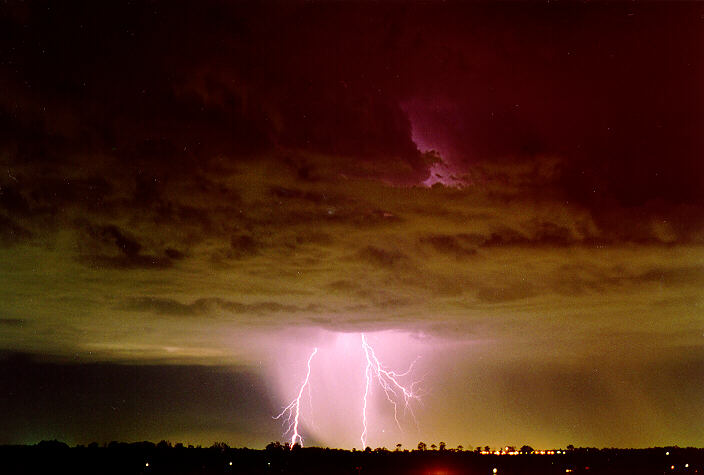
left=0, top=2, right=704, bottom=249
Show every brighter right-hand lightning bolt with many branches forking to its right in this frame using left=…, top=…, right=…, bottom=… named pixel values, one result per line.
left=360, top=333, right=419, bottom=449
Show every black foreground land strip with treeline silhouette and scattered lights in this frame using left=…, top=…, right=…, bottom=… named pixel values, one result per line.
left=0, top=442, right=704, bottom=475
